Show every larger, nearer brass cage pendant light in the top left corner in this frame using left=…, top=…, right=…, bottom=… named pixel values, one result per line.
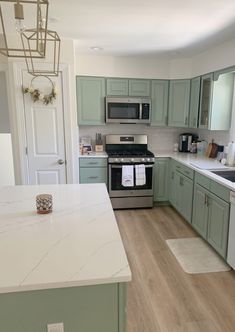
left=0, top=0, right=49, bottom=58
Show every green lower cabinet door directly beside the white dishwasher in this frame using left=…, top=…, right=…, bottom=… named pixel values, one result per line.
left=207, top=194, right=229, bottom=258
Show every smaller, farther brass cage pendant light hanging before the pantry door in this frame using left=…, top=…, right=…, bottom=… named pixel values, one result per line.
left=21, top=27, right=60, bottom=76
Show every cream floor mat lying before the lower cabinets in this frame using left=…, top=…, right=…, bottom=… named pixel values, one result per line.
left=166, top=237, right=231, bottom=274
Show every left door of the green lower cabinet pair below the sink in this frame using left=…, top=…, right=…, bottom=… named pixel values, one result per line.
left=192, top=184, right=209, bottom=239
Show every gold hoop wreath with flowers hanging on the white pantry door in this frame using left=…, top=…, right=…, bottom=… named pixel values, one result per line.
left=23, top=75, right=58, bottom=105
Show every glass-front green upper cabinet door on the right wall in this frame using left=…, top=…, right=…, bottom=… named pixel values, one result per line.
left=199, top=74, right=213, bottom=128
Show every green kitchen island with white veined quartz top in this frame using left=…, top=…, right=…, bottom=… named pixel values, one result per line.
left=0, top=184, right=131, bottom=332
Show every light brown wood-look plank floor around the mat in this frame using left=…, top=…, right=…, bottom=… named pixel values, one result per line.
left=115, top=207, right=235, bottom=332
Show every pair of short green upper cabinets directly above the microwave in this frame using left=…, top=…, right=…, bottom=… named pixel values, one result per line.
left=106, top=78, right=150, bottom=97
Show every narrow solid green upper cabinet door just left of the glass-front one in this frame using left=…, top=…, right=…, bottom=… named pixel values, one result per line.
left=189, top=77, right=201, bottom=128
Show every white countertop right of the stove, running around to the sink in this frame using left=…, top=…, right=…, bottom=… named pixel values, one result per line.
left=152, top=150, right=235, bottom=191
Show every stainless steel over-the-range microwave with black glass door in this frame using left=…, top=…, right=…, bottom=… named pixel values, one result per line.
left=106, top=97, right=151, bottom=123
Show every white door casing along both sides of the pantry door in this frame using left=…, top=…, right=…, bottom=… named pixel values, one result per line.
left=8, top=61, right=78, bottom=184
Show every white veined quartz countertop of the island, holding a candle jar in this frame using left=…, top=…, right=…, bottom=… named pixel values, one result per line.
left=0, top=184, right=131, bottom=293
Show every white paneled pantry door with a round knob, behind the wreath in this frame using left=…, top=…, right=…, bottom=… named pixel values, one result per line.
left=22, top=71, right=67, bottom=184
